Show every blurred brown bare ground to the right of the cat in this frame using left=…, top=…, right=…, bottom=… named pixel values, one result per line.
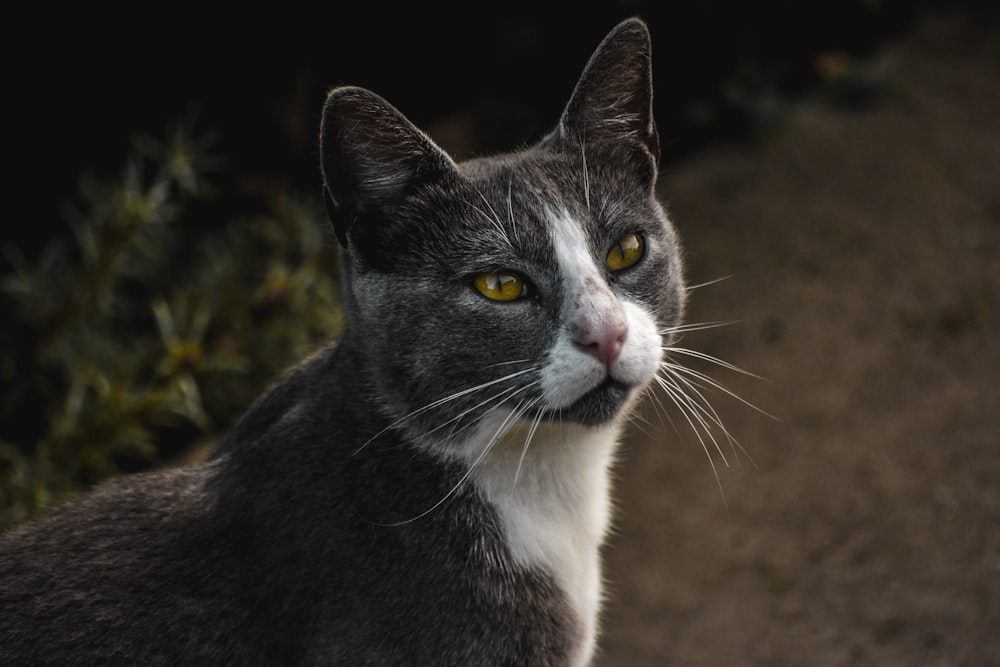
left=599, top=13, right=1000, bottom=666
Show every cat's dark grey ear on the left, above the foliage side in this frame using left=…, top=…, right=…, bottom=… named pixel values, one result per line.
left=320, top=86, right=455, bottom=247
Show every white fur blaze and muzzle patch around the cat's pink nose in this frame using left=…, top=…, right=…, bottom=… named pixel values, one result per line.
left=541, top=210, right=663, bottom=410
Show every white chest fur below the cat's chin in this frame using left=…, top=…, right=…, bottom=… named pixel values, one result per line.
left=458, top=423, right=619, bottom=665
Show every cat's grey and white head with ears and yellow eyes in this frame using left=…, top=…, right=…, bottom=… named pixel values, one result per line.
left=321, top=19, right=685, bottom=435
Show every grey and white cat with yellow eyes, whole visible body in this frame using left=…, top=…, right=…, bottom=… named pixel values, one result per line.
left=0, top=19, right=685, bottom=666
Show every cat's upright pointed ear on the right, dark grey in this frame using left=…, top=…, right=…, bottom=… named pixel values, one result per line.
left=548, top=18, right=660, bottom=180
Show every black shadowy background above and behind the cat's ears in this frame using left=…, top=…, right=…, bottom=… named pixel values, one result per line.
left=4, top=0, right=929, bottom=257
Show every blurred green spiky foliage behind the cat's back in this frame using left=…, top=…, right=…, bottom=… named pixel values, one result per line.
left=0, top=125, right=342, bottom=530
